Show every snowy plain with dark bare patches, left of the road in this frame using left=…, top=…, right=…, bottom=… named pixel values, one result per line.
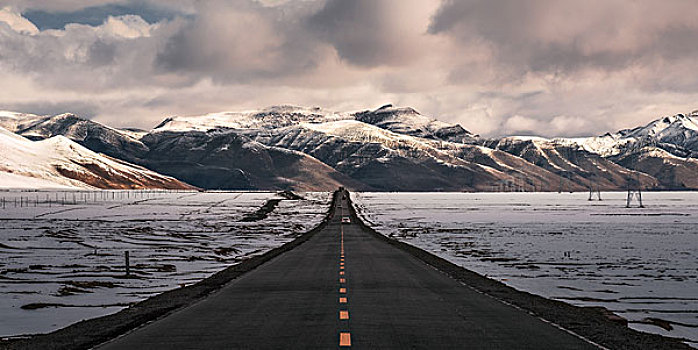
left=0, top=191, right=331, bottom=336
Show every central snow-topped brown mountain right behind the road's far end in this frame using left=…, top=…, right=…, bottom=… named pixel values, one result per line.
left=247, top=120, right=558, bottom=191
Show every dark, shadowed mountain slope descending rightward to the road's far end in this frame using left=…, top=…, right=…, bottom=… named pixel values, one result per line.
left=142, top=129, right=368, bottom=191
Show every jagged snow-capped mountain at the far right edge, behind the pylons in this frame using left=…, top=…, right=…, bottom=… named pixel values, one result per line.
left=476, top=111, right=698, bottom=189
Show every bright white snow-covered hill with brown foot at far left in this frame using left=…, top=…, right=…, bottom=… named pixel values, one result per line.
left=0, top=128, right=192, bottom=189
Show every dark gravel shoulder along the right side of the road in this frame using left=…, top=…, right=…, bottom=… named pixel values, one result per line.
left=345, top=191, right=692, bottom=350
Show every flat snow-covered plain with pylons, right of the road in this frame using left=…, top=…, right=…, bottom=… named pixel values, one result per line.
left=353, top=192, right=698, bottom=347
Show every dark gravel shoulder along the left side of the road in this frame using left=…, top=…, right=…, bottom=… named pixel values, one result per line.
left=0, top=190, right=340, bottom=350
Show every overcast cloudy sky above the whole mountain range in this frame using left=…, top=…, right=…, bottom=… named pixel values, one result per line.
left=0, top=0, right=698, bottom=136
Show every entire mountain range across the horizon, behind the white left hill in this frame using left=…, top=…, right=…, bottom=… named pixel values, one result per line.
left=0, top=105, right=698, bottom=191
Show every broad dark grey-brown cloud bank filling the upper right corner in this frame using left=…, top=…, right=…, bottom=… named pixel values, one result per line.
left=430, top=0, right=698, bottom=79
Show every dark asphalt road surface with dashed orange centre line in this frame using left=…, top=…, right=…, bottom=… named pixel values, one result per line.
left=99, top=196, right=596, bottom=349
